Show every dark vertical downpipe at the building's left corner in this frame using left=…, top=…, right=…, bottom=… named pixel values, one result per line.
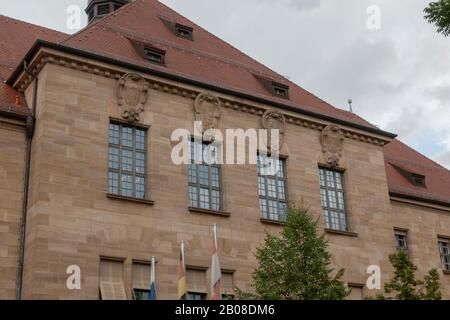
left=16, top=62, right=38, bottom=300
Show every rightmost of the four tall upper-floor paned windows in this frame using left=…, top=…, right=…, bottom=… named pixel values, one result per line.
left=319, top=168, right=348, bottom=231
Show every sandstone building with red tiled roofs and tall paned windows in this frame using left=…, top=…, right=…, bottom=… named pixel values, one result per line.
left=0, top=0, right=450, bottom=299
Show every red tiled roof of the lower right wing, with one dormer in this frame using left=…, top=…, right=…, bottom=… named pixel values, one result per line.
left=384, top=139, right=450, bottom=205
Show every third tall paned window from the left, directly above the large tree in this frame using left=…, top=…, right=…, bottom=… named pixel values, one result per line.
left=257, top=155, right=287, bottom=221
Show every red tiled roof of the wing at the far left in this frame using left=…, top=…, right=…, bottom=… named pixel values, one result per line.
left=0, top=15, right=67, bottom=114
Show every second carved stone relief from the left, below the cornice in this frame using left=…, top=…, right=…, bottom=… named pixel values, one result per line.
left=194, top=93, right=222, bottom=138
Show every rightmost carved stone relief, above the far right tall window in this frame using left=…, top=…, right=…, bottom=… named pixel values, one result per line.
left=320, top=125, right=344, bottom=167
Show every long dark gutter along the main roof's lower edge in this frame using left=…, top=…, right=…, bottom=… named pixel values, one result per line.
left=6, top=40, right=397, bottom=139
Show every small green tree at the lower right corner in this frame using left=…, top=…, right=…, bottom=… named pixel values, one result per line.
left=377, top=250, right=441, bottom=300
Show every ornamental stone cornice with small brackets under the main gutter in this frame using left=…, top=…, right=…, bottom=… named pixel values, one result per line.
left=14, top=48, right=392, bottom=146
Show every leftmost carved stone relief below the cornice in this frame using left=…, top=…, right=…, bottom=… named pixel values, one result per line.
left=117, top=73, right=149, bottom=122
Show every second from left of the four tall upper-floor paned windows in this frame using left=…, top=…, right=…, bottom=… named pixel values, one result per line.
left=188, top=140, right=223, bottom=211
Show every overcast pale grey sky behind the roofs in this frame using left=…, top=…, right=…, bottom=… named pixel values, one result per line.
left=0, top=0, right=450, bottom=169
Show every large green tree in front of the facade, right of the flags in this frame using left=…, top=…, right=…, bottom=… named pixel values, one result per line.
left=251, top=203, right=350, bottom=300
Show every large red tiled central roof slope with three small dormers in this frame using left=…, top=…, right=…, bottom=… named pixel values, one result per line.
left=62, top=0, right=374, bottom=127
